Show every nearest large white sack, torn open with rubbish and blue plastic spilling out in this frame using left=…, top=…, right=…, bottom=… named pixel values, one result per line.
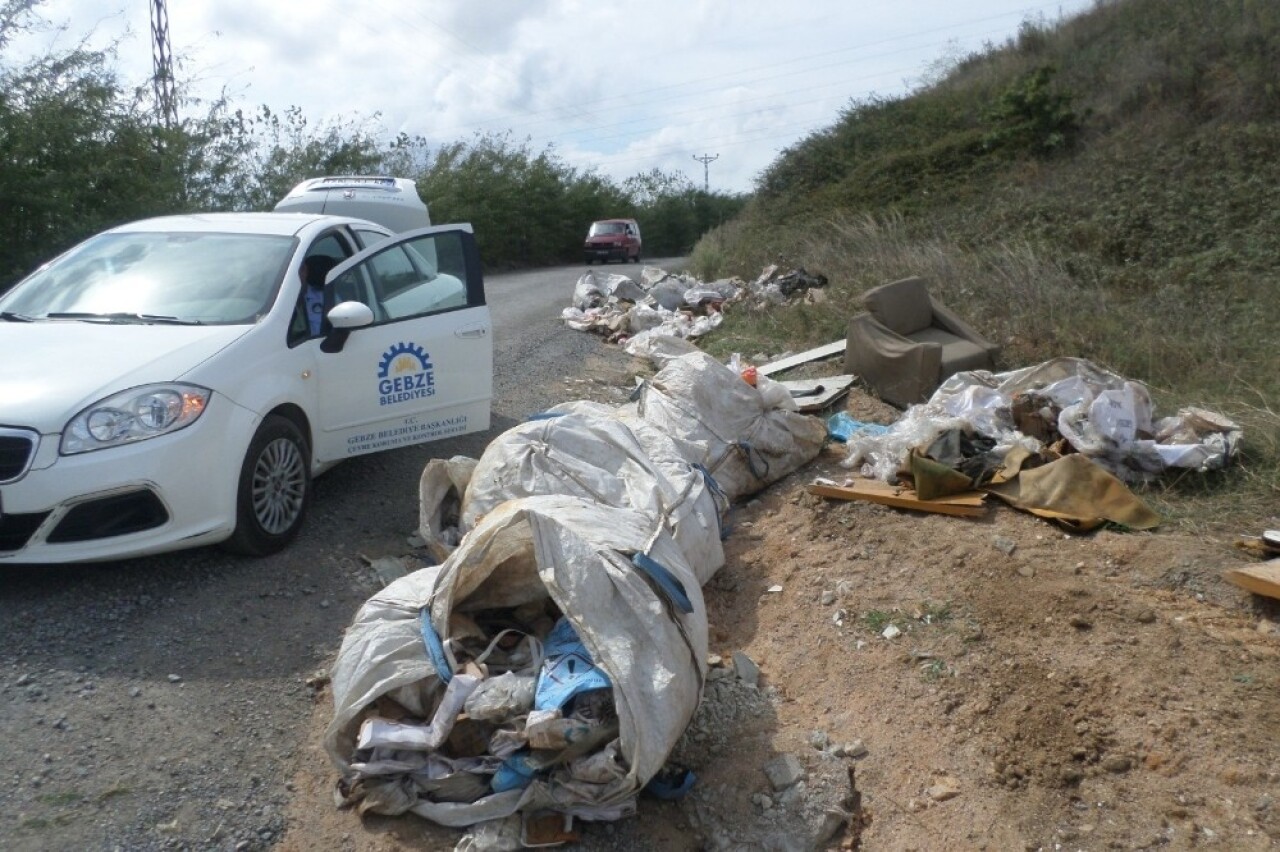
left=325, top=496, right=707, bottom=826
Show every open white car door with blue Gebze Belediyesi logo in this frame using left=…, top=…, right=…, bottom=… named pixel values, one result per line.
left=312, top=218, right=493, bottom=462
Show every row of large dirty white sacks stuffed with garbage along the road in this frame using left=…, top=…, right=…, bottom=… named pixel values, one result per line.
left=325, top=352, right=826, bottom=848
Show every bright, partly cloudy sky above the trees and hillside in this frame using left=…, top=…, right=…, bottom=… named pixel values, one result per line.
left=5, top=0, right=1093, bottom=192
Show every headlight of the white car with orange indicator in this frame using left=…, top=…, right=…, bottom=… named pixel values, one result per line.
left=61, top=383, right=214, bottom=455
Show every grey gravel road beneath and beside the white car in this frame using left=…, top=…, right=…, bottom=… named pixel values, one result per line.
left=0, top=261, right=678, bottom=852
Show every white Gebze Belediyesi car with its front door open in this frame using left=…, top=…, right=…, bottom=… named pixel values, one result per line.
left=0, top=178, right=493, bottom=564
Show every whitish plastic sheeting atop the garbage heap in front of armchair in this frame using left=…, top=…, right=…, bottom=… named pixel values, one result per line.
left=844, top=358, right=1242, bottom=482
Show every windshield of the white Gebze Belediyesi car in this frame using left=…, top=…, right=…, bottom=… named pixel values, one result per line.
left=0, top=232, right=294, bottom=324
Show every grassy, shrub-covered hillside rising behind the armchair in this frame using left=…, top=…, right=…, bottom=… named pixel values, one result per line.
left=694, top=0, right=1280, bottom=526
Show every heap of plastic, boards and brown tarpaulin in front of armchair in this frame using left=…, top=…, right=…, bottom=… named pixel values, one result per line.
left=829, top=358, right=1242, bottom=532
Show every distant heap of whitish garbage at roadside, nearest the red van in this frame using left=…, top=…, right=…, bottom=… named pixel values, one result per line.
left=561, top=265, right=827, bottom=354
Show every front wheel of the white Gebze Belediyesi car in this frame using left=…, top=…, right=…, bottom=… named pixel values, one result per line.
left=225, top=414, right=311, bottom=556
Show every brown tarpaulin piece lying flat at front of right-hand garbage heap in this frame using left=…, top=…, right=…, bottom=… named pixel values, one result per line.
left=987, top=453, right=1160, bottom=532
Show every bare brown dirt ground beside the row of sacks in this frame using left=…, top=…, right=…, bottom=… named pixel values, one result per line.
left=279, top=385, right=1280, bottom=852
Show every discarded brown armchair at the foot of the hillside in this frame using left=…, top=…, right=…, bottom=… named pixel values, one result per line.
left=845, top=272, right=1000, bottom=407
